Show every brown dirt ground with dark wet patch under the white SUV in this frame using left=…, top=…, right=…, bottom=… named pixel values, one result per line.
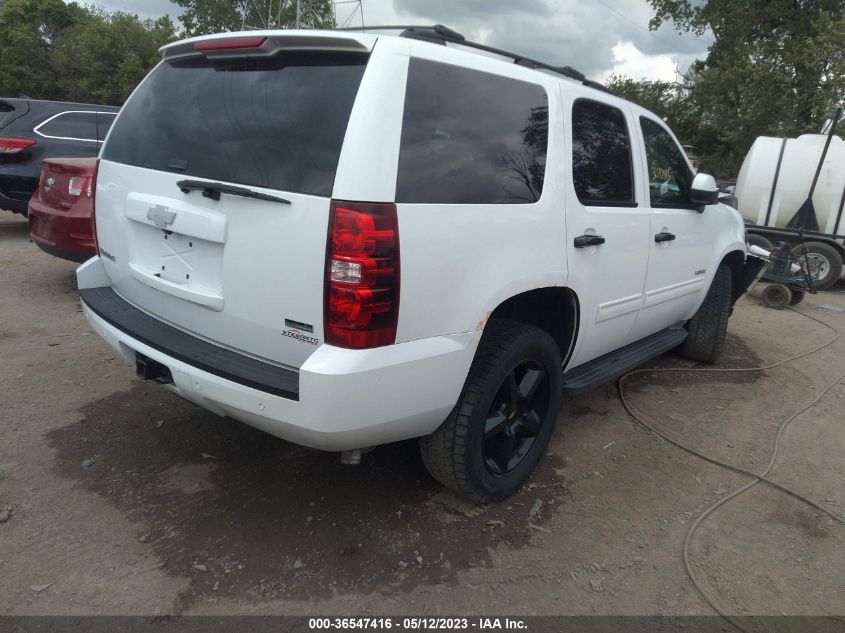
left=0, top=212, right=845, bottom=615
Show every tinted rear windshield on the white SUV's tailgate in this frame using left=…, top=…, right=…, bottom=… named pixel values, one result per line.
left=102, top=52, right=367, bottom=196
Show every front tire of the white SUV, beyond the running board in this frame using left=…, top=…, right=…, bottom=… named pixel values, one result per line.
left=680, top=264, right=733, bottom=363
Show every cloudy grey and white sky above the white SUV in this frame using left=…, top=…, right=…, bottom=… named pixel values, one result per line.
left=79, top=0, right=711, bottom=81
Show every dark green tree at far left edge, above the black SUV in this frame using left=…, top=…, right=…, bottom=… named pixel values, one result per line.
left=0, top=0, right=94, bottom=99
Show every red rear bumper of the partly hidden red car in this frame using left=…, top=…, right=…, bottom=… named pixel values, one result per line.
left=29, top=196, right=97, bottom=262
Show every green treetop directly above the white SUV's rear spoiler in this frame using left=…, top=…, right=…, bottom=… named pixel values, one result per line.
left=172, top=0, right=334, bottom=36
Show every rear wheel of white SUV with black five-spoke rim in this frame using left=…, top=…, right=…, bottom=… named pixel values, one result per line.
left=420, top=319, right=562, bottom=503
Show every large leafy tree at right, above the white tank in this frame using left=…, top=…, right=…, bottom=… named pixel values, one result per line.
left=648, top=0, right=845, bottom=175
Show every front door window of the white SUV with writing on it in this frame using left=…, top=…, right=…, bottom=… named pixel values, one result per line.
left=640, top=117, right=693, bottom=206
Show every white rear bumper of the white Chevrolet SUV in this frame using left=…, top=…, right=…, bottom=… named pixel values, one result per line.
left=77, top=258, right=481, bottom=450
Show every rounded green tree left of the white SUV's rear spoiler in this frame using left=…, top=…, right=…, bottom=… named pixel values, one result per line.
left=52, top=12, right=177, bottom=105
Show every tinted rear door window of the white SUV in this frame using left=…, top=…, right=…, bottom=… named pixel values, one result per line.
left=572, top=99, right=636, bottom=206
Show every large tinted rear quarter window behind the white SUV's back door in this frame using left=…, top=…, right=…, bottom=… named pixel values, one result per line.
left=396, top=59, right=549, bottom=204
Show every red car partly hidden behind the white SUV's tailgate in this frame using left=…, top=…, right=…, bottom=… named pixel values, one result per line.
left=29, top=158, right=97, bottom=262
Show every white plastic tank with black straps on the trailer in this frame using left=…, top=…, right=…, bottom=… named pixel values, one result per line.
left=736, top=134, right=845, bottom=234
